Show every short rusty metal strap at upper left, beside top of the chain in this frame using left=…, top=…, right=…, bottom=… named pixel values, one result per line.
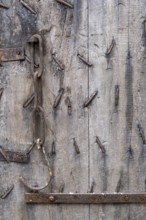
left=0, top=47, right=25, bottom=62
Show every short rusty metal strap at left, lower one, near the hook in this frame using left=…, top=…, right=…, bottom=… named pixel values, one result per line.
left=0, top=149, right=29, bottom=163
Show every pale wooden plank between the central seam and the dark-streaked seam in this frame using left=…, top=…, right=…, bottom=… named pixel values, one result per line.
left=88, top=0, right=131, bottom=219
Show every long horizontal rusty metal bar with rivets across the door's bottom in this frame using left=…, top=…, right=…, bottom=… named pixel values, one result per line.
left=25, top=193, right=146, bottom=204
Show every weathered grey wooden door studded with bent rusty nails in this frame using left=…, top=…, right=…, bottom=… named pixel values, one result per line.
left=0, top=0, right=146, bottom=220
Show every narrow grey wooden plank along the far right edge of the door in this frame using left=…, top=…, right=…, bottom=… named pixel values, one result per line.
left=126, top=0, right=146, bottom=219
